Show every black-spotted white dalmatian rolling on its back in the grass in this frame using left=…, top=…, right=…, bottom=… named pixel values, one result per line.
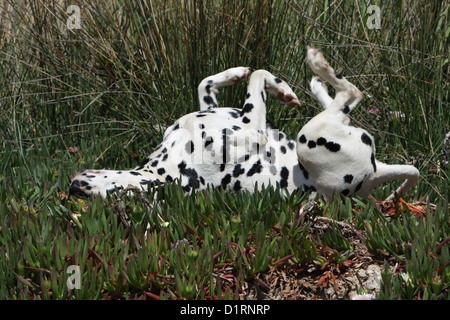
left=69, top=47, right=419, bottom=199
